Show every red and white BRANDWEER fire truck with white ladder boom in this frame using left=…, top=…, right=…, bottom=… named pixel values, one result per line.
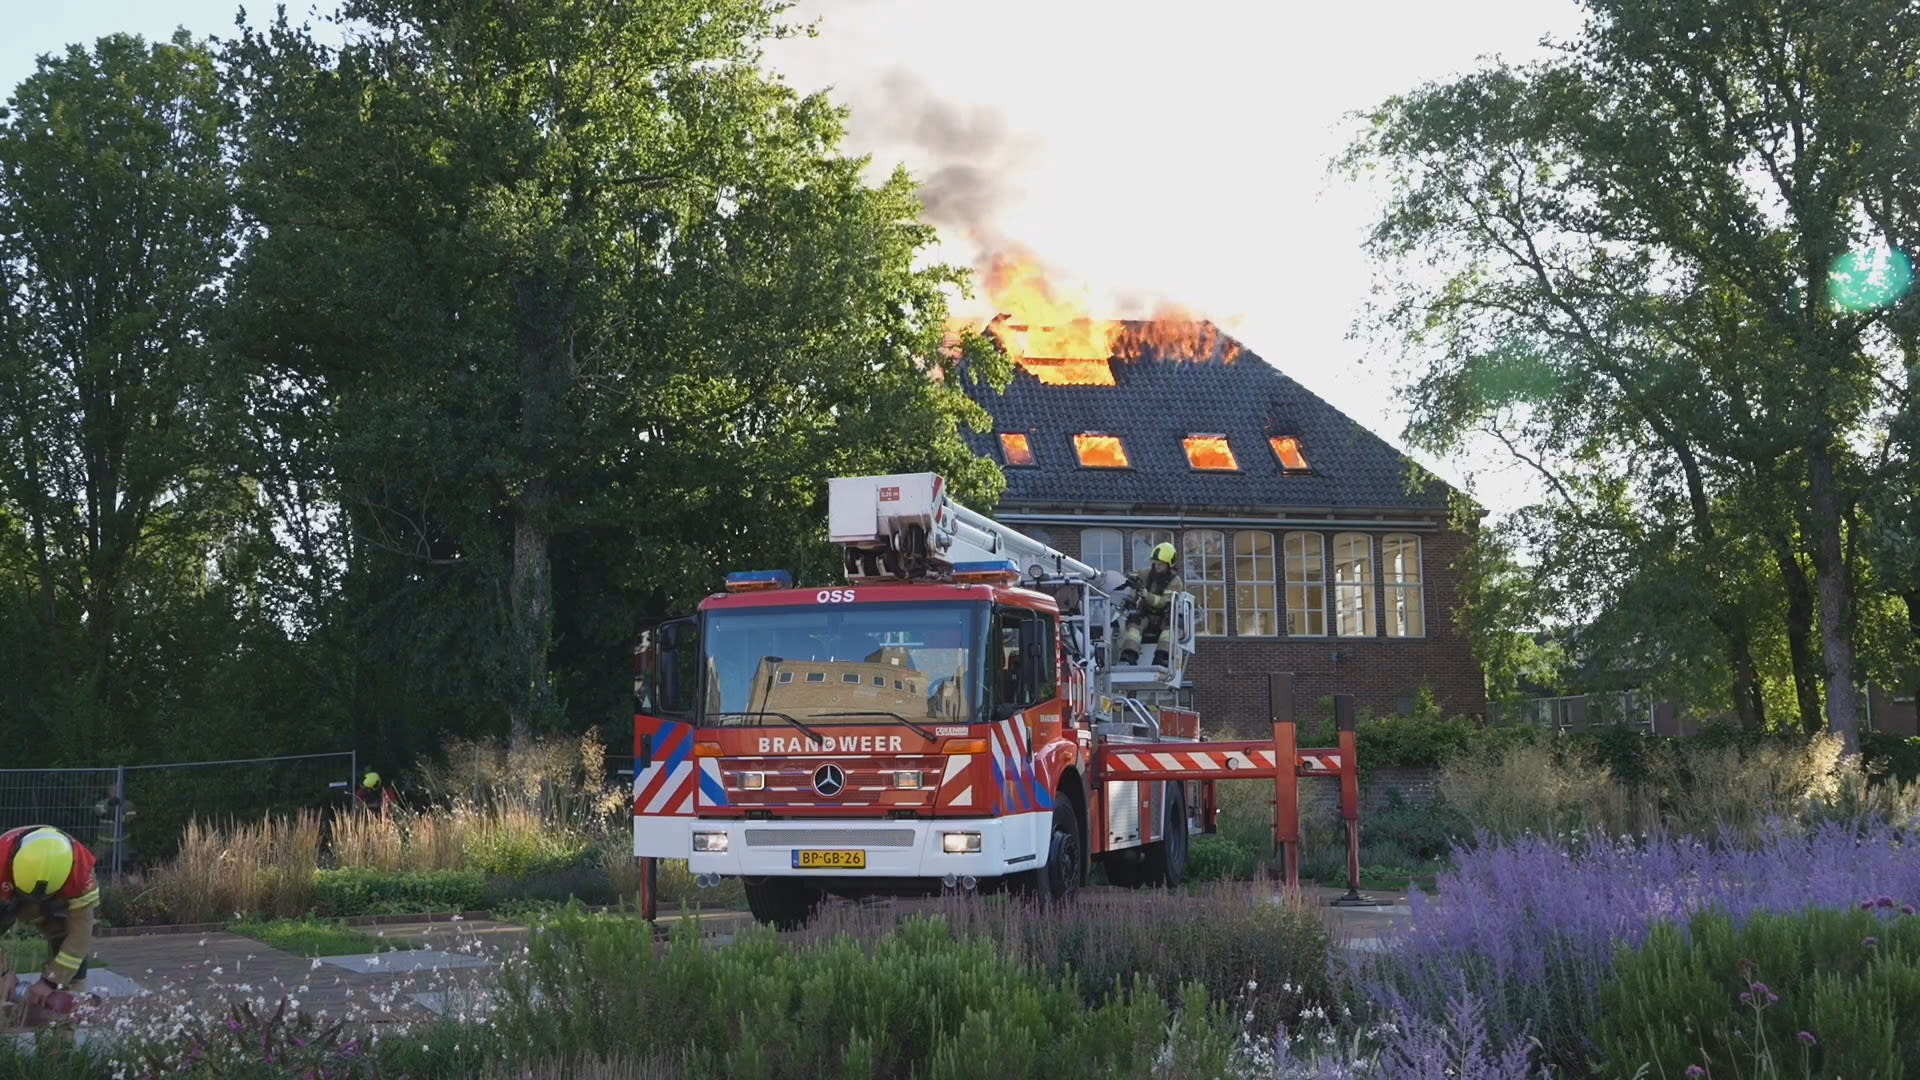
left=634, top=473, right=1244, bottom=926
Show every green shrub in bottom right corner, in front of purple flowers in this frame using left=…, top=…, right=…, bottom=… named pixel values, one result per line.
left=1597, top=897, right=1920, bottom=1076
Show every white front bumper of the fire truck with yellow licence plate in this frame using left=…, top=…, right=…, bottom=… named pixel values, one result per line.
left=687, top=813, right=1052, bottom=878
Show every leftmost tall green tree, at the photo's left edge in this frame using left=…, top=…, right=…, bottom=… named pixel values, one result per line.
left=0, top=33, right=234, bottom=749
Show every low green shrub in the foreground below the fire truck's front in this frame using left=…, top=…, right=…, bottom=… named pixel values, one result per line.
left=480, top=899, right=1235, bottom=1080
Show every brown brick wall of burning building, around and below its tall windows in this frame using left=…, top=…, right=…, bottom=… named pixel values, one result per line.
left=1023, top=521, right=1486, bottom=736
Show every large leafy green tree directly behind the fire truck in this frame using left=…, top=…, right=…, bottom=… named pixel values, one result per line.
left=228, top=0, right=1006, bottom=736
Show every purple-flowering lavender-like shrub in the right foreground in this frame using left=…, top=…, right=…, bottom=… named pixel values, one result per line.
left=1352, top=822, right=1920, bottom=1072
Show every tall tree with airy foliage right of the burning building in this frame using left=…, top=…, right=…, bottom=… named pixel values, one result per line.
left=1350, top=0, right=1920, bottom=749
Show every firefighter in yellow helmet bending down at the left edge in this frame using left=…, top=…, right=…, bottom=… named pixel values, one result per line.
left=0, top=824, right=100, bottom=1017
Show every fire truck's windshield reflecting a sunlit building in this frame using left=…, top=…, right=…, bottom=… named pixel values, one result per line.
left=703, top=603, right=985, bottom=726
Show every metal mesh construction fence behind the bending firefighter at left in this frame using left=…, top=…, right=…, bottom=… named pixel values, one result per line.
left=0, top=751, right=359, bottom=878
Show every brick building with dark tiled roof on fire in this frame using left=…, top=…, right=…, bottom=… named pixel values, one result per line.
left=972, top=323, right=1486, bottom=730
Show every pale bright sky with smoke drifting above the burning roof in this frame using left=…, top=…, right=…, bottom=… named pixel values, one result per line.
left=0, top=0, right=1578, bottom=515
